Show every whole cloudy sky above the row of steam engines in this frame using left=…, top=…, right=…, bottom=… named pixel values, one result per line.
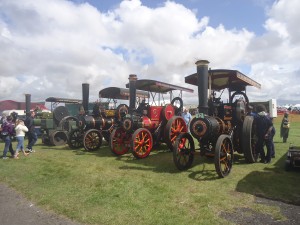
left=0, top=0, right=300, bottom=104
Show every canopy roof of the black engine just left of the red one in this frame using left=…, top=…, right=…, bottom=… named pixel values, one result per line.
left=99, top=87, right=149, bottom=100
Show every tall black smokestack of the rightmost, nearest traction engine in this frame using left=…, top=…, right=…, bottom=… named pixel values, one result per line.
left=196, top=60, right=209, bottom=115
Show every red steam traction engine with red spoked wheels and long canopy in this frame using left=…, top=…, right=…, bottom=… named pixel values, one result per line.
left=110, top=75, right=193, bottom=158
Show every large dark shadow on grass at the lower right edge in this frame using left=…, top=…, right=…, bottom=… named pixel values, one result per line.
left=236, top=151, right=300, bottom=205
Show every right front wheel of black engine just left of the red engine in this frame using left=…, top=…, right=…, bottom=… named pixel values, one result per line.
left=83, top=129, right=102, bottom=151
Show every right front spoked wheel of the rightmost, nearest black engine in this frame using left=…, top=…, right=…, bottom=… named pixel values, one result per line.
left=215, top=134, right=233, bottom=178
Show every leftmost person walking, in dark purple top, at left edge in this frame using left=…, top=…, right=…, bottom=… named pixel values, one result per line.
left=1, top=116, right=14, bottom=159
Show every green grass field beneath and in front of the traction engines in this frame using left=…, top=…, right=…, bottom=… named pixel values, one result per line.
left=0, top=115, right=300, bottom=225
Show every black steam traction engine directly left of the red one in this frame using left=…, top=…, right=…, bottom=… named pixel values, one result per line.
left=62, top=84, right=148, bottom=151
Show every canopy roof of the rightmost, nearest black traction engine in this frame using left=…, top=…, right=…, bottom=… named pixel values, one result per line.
left=185, top=69, right=261, bottom=91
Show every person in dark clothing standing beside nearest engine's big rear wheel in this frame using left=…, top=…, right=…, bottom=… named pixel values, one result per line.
left=255, top=105, right=273, bottom=163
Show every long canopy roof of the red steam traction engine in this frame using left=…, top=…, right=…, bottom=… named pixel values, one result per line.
left=126, top=79, right=194, bottom=93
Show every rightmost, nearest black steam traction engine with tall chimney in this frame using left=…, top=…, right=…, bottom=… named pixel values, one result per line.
left=173, top=60, right=260, bottom=177
